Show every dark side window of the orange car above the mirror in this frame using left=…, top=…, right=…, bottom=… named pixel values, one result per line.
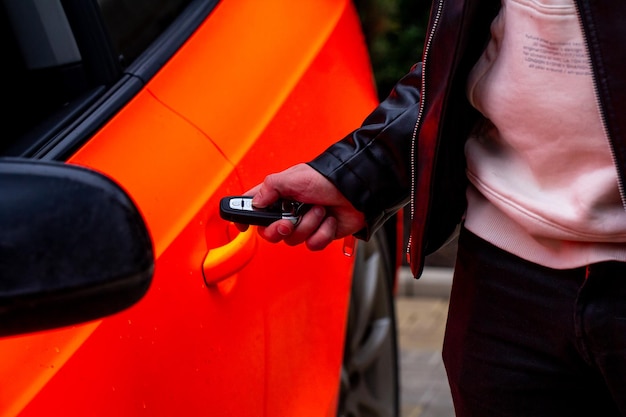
left=0, top=0, right=192, bottom=157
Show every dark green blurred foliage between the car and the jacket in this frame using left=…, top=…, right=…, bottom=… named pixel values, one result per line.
left=354, top=0, right=430, bottom=99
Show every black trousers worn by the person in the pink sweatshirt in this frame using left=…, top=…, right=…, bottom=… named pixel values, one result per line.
left=443, top=230, right=626, bottom=417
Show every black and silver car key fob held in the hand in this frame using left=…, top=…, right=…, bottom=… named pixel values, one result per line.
left=220, top=196, right=312, bottom=226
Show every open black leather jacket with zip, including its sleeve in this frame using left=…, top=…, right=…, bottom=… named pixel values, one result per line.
left=310, top=0, right=626, bottom=276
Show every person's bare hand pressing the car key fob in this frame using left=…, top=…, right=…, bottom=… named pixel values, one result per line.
left=240, top=164, right=365, bottom=250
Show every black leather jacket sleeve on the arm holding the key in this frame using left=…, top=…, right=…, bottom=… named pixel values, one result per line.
left=309, top=64, right=422, bottom=239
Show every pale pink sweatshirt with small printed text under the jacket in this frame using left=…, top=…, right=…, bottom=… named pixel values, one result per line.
left=465, top=0, right=626, bottom=268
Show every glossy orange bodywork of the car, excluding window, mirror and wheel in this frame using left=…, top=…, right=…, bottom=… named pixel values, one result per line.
left=0, top=0, right=376, bottom=417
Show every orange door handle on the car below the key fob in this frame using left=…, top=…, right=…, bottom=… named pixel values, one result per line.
left=202, top=227, right=257, bottom=285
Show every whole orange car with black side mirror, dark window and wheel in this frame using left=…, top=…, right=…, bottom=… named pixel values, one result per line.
left=0, top=0, right=398, bottom=417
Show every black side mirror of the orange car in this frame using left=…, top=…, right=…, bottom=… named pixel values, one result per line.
left=0, top=158, right=154, bottom=336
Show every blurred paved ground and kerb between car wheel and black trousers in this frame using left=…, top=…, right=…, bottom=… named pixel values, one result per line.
left=397, top=268, right=454, bottom=417
